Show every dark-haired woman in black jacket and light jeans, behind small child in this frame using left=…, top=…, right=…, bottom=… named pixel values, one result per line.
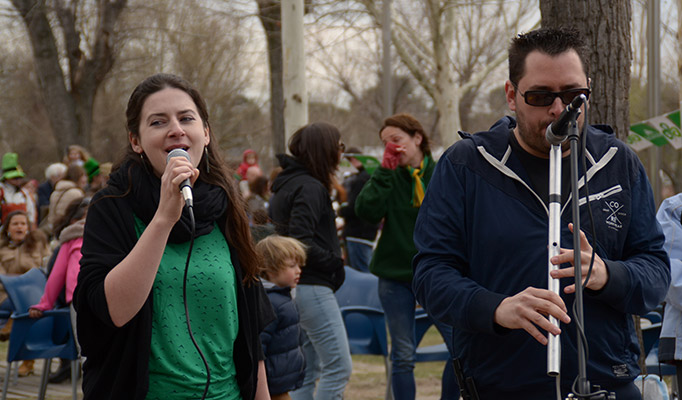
left=268, top=122, right=352, bottom=400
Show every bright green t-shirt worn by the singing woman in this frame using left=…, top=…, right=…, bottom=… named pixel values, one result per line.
left=136, top=218, right=241, bottom=400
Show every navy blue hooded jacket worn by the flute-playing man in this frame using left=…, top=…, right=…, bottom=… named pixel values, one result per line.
left=413, top=117, right=670, bottom=399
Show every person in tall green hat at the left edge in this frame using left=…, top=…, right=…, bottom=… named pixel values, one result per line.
left=0, top=153, right=38, bottom=227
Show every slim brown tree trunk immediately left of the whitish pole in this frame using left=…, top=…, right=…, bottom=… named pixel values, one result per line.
left=257, top=0, right=286, bottom=157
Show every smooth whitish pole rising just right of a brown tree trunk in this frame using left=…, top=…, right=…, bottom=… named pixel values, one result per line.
left=282, top=0, right=308, bottom=147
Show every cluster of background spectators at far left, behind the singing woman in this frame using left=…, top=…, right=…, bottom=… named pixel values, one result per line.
left=0, top=145, right=111, bottom=383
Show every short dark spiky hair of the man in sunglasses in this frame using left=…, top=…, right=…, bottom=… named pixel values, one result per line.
left=509, top=27, right=589, bottom=86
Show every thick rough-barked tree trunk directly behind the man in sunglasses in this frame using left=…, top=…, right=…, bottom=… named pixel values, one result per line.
left=540, top=0, right=632, bottom=140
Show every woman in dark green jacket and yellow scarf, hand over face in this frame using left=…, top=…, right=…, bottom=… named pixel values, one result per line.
left=355, top=114, right=451, bottom=400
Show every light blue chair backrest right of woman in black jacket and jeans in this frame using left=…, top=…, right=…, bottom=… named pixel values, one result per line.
left=335, top=266, right=382, bottom=310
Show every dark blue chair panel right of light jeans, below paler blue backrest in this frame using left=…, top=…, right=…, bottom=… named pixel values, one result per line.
left=341, top=306, right=388, bottom=356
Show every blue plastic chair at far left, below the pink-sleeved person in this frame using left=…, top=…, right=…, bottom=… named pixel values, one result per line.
left=0, top=268, right=78, bottom=400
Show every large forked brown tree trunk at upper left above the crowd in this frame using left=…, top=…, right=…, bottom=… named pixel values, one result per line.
left=12, top=0, right=127, bottom=157
